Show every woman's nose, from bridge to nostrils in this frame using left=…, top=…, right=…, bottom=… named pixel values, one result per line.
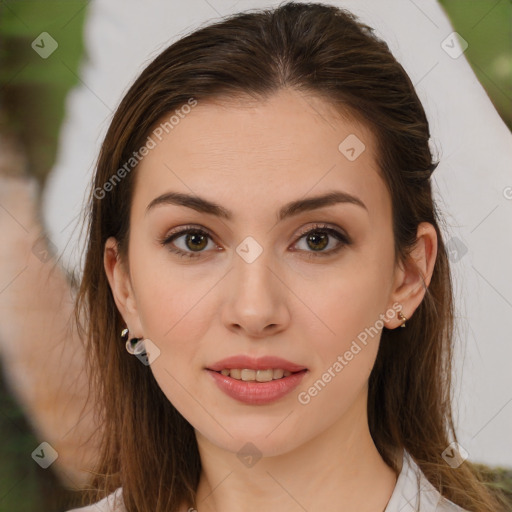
left=221, top=247, right=290, bottom=339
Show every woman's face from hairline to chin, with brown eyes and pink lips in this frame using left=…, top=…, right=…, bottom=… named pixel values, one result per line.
left=107, top=90, right=414, bottom=455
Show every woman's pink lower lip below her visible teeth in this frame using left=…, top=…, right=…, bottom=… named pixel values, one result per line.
left=206, top=370, right=307, bottom=405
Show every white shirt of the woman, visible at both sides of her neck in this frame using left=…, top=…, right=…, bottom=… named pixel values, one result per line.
left=68, top=450, right=468, bottom=512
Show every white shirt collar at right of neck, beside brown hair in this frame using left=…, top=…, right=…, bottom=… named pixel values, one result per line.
left=384, top=450, right=468, bottom=512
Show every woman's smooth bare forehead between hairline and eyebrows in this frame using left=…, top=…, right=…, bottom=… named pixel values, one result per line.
left=132, top=90, right=390, bottom=220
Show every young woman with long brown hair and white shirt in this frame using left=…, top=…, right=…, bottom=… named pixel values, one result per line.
left=68, top=3, right=504, bottom=512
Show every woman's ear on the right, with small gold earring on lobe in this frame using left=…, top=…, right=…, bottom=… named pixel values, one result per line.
left=386, top=222, right=437, bottom=329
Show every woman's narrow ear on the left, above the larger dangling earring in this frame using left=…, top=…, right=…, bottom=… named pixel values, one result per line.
left=103, top=237, right=144, bottom=338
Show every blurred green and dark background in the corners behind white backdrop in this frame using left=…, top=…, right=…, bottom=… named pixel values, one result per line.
left=0, top=0, right=512, bottom=512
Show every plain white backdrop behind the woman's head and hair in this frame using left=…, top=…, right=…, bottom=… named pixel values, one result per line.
left=43, top=0, right=512, bottom=466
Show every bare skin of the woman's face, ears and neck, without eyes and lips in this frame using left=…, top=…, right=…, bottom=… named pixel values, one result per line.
left=105, top=89, right=437, bottom=512
